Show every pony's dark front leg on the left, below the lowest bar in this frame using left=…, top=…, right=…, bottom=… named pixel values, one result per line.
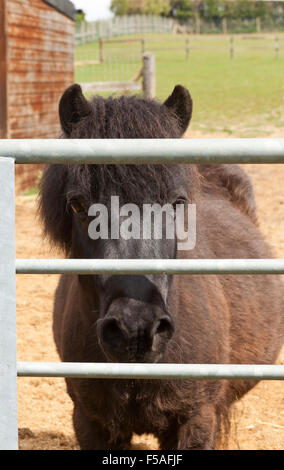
left=73, top=405, right=131, bottom=450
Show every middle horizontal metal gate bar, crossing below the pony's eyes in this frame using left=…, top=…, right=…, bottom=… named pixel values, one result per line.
left=16, top=259, right=284, bottom=274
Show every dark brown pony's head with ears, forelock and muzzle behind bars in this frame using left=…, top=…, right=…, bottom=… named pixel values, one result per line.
left=40, top=85, right=198, bottom=362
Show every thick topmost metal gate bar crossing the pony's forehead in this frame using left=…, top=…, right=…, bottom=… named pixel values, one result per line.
left=0, top=139, right=284, bottom=164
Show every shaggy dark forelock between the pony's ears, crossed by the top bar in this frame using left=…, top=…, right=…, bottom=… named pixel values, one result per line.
left=65, top=96, right=199, bottom=204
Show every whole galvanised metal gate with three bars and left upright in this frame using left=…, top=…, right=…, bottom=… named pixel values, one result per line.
left=0, top=139, right=284, bottom=449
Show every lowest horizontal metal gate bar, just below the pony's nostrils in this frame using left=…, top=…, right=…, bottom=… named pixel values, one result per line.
left=17, top=362, right=284, bottom=380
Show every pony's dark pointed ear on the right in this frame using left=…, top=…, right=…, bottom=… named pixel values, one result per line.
left=164, top=85, right=192, bottom=134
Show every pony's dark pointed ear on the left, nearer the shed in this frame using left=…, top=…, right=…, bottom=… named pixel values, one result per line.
left=59, top=83, right=91, bottom=136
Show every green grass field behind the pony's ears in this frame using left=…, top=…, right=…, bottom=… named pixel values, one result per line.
left=75, top=34, right=284, bottom=137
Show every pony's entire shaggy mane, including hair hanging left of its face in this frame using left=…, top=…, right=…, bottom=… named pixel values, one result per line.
left=39, top=92, right=199, bottom=254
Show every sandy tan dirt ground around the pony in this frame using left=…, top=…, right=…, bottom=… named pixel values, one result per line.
left=16, top=130, right=284, bottom=450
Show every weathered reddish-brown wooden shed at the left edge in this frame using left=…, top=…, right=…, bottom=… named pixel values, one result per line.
left=0, top=0, right=75, bottom=189
